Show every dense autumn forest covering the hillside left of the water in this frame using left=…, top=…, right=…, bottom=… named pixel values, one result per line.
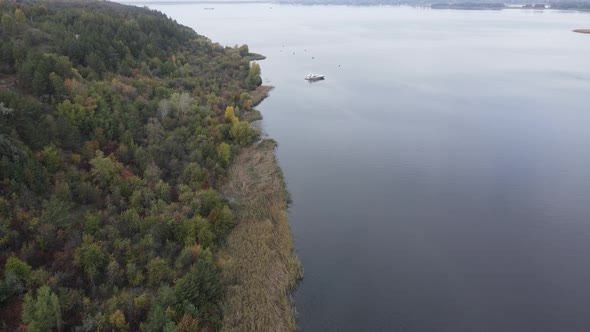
left=0, top=2, right=268, bottom=331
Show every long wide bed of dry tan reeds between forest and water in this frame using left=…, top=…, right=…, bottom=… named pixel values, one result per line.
left=219, top=140, right=303, bottom=331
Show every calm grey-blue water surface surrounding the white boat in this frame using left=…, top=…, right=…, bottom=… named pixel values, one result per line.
left=140, top=4, right=590, bottom=332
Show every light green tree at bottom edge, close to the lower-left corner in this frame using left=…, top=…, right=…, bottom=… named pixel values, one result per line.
left=22, top=286, right=61, bottom=332
